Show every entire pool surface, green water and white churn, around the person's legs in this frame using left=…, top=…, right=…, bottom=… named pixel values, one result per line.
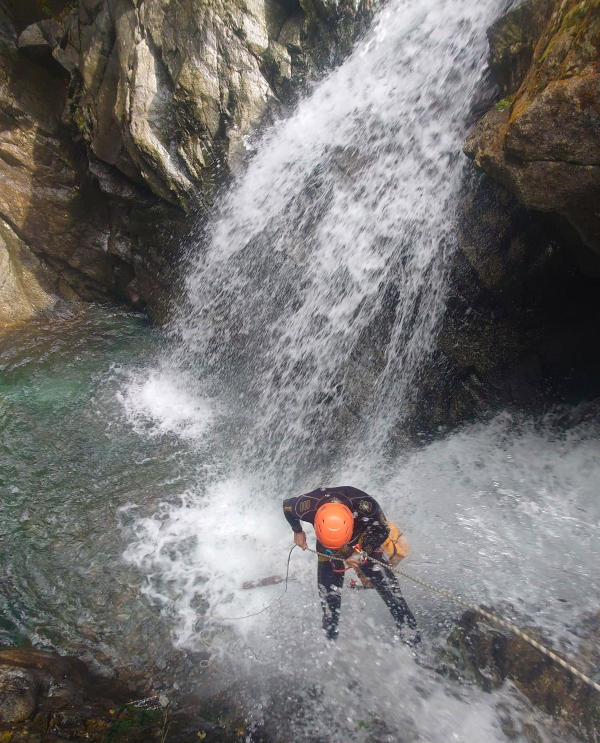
left=0, top=317, right=600, bottom=743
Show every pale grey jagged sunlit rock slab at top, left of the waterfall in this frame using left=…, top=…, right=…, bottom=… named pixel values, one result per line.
left=68, top=0, right=372, bottom=207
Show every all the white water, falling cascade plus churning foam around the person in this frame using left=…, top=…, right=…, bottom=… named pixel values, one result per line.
left=118, top=0, right=600, bottom=742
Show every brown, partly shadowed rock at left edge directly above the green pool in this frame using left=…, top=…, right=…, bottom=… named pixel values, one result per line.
left=0, top=3, right=184, bottom=325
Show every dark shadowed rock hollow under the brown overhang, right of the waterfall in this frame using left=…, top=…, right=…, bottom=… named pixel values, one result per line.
left=398, top=160, right=600, bottom=440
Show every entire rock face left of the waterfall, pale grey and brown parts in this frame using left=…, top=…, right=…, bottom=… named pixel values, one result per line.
left=0, top=0, right=371, bottom=325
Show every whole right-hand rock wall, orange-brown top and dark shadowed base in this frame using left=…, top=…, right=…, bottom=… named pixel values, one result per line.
left=398, top=0, right=600, bottom=433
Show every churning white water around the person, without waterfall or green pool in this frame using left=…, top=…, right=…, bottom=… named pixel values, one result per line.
left=123, top=414, right=600, bottom=741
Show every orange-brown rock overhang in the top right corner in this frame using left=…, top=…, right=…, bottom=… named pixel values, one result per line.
left=465, top=0, right=600, bottom=264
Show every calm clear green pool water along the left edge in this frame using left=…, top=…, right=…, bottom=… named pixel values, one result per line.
left=0, top=307, right=196, bottom=680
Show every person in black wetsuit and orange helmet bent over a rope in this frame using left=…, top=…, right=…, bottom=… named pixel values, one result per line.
left=283, top=486, right=420, bottom=645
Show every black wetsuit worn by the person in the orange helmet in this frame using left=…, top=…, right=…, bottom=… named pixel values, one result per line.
left=283, top=486, right=418, bottom=643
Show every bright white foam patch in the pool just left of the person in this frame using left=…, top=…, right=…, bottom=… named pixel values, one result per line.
left=125, top=478, right=298, bottom=647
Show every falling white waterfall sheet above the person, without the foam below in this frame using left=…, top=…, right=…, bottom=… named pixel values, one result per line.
left=163, top=0, right=498, bottom=476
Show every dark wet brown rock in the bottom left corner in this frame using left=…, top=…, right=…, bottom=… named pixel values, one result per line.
left=0, top=648, right=251, bottom=743
